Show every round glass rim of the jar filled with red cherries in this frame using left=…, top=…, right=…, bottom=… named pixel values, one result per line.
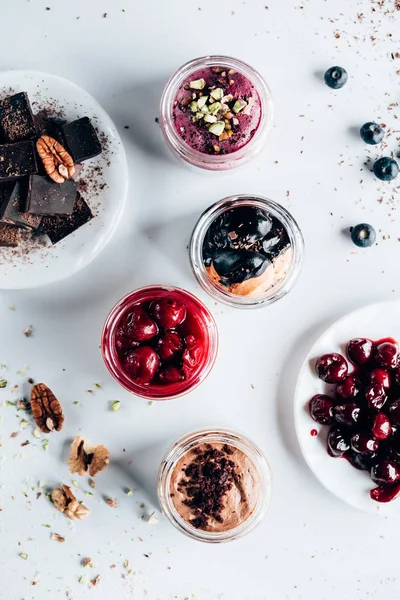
left=101, top=284, right=219, bottom=401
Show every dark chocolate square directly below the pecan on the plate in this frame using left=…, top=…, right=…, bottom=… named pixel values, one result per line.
left=26, top=175, right=78, bottom=215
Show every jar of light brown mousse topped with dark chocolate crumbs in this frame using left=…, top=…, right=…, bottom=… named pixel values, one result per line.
left=158, top=429, right=272, bottom=543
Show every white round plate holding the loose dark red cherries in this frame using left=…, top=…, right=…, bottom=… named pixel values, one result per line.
left=294, top=301, right=400, bottom=515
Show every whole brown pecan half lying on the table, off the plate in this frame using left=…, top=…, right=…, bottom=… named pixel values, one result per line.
left=31, top=383, right=64, bottom=433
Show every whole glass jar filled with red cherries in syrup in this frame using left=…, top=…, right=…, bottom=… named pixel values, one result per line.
left=101, top=285, right=218, bottom=400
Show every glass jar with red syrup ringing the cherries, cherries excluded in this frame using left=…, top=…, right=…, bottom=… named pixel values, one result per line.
left=101, top=285, right=218, bottom=400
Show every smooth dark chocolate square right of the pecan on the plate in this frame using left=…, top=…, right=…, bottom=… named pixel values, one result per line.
left=61, top=117, right=101, bottom=162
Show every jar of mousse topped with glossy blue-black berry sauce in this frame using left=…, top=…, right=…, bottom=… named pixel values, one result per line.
left=189, top=194, right=304, bottom=308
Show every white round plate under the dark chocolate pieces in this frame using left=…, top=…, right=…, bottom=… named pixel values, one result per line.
left=0, top=71, right=128, bottom=289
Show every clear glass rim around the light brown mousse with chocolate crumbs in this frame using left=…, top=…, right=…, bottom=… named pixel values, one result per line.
left=158, top=429, right=272, bottom=543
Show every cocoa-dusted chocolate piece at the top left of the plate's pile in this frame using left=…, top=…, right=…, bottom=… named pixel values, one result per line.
left=0, top=92, right=36, bottom=143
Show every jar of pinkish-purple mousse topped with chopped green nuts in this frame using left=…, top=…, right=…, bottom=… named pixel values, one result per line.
left=160, top=56, right=273, bottom=171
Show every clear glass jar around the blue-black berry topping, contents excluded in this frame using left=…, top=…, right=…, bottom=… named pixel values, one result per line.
left=189, top=194, right=304, bottom=308
